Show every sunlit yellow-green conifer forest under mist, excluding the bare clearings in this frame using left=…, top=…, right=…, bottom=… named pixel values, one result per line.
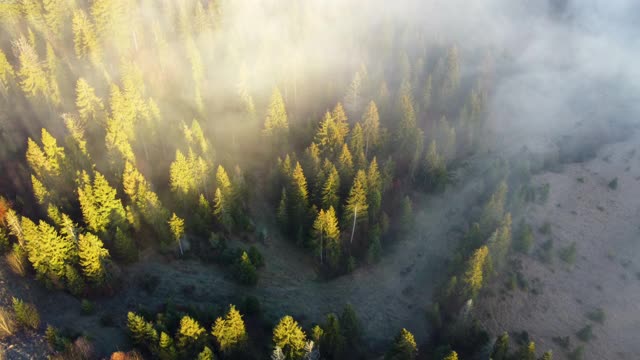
left=0, top=0, right=636, bottom=360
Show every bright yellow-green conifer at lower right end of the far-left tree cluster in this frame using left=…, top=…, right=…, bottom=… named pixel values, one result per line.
left=78, top=233, right=109, bottom=285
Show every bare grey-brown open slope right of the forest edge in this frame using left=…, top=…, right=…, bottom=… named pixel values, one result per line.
left=477, top=129, right=640, bottom=360
